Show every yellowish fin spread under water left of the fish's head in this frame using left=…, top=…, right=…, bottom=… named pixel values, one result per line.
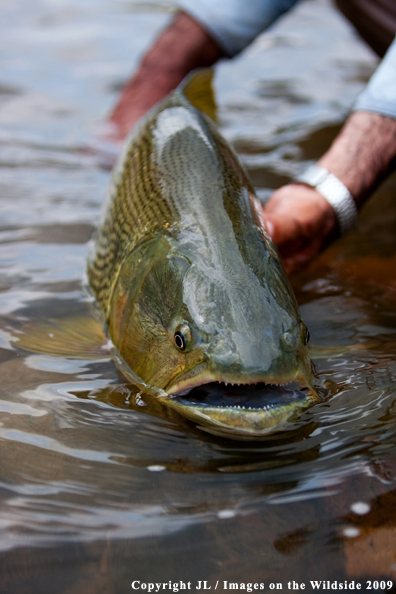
left=7, top=316, right=110, bottom=360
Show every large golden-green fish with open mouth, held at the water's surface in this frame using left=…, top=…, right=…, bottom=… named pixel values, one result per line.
left=88, top=71, right=319, bottom=439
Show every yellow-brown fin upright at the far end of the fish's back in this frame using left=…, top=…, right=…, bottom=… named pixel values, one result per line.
left=179, top=68, right=217, bottom=122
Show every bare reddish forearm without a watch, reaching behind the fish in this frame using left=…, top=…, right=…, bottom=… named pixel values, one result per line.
left=109, top=12, right=224, bottom=140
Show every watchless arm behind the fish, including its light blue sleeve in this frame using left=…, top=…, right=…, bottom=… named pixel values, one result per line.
left=108, top=0, right=298, bottom=141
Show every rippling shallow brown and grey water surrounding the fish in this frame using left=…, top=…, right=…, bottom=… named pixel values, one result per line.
left=0, top=0, right=396, bottom=594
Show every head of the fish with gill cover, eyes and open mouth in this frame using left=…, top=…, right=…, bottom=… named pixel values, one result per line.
left=109, top=231, right=318, bottom=439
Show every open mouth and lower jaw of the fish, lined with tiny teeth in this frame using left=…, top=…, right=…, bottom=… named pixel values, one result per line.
left=161, top=381, right=320, bottom=440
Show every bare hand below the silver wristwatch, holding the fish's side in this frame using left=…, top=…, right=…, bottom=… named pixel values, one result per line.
left=262, top=183, right=337, bottom=274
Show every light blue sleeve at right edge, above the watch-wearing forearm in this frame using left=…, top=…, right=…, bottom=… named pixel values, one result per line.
left=353, top=39, right=396, bottom=118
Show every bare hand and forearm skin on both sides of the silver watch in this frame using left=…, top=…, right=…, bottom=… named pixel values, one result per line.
left=262, top=112, right=396, bottom=274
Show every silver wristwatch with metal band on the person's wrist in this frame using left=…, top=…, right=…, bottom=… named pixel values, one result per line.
left=295, top=165, right=357, bottom=235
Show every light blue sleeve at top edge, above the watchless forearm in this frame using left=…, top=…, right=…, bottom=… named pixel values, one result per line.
left=178, top=0, right=298, bottom=57
